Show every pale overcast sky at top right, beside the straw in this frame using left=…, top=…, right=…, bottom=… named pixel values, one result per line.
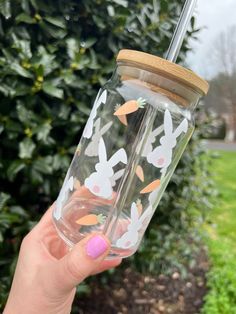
left=186, top=0, right=236, bottom=79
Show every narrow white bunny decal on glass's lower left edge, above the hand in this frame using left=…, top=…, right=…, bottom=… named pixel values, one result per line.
left=54, top=172, right=74, bottom=220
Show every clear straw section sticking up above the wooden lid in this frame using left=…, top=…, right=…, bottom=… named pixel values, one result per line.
left=165, top=0, right=197, bottom=62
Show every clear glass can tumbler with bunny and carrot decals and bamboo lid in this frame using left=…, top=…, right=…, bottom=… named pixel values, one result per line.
left=53, top=50, right=208, bottom=258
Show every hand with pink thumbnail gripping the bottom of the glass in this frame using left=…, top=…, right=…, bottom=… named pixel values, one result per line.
left=3, top=206, right=121, bottom=314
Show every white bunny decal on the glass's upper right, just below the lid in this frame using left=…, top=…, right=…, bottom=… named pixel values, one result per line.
left=147, top=109, right=188, bottom=172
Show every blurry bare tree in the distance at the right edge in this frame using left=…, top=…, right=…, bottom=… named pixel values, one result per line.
left=205, top=25, right=236, bottom=141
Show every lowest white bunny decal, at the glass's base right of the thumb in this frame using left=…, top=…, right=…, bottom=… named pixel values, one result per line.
left=116, top=202, right=152, bottom=249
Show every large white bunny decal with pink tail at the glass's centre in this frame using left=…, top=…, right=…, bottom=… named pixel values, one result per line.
left=84, top=137, right=127, bottom=199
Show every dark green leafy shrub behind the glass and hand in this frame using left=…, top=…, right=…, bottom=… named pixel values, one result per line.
left=0, top=0, right=211, bottom=305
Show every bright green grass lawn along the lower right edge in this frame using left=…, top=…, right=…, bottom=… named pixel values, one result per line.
left=202, top=151, right=236, bottom=314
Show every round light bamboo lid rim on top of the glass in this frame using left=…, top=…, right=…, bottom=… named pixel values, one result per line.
left=116, top=49, right=209, bottom=95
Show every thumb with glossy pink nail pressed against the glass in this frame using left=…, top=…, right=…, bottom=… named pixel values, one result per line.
left=53, top=234, right=110, bottom=293
